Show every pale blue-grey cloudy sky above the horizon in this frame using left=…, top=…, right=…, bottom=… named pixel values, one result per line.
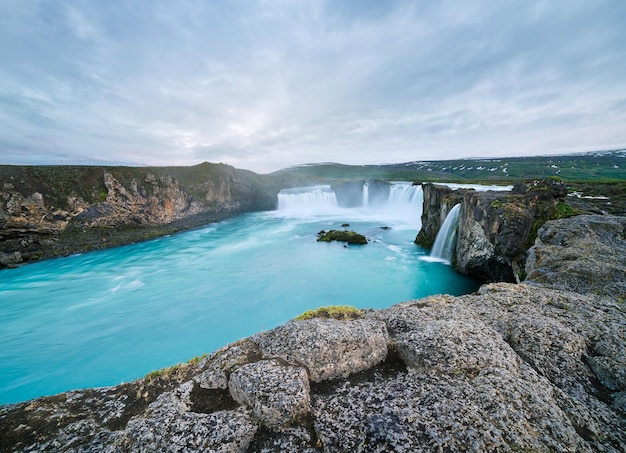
left=0, top=0, right=626, bottom=172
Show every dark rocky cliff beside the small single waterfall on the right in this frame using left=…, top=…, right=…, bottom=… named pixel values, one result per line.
left=416, top=179, right=574, bottom=282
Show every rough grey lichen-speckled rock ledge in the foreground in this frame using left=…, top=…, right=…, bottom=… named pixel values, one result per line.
left=0, top=216, right=626, bottom=452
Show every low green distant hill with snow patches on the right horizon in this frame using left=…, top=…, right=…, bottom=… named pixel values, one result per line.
left=275, top=149, right=626, bottom=182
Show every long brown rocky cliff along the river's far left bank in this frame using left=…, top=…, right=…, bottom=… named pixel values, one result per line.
left=0, top=163, right=312, bottom=268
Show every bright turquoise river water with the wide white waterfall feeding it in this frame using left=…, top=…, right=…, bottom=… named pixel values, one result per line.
left=0, top=183, right=478, bottom=404
